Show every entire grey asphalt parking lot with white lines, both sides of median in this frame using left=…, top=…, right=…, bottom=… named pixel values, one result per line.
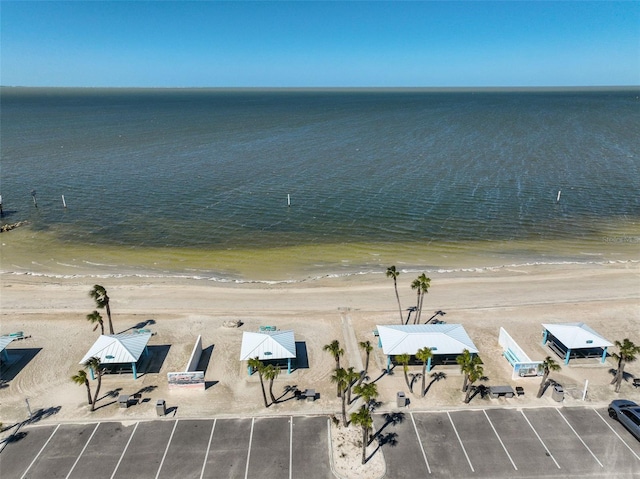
left=0, top=408, right=640, bottom=479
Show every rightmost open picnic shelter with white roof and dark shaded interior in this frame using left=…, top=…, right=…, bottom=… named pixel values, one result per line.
left=542, top=323, right=613, bottom=364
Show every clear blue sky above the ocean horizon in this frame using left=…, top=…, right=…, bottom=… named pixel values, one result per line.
left=0, top=0, right=640, bottom=87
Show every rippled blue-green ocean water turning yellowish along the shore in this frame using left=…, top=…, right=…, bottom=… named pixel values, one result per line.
left=0, top=88, right=640, bottom=280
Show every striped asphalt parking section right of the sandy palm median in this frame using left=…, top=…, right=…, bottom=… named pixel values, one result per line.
left=376, top=408, right=640, bottom=479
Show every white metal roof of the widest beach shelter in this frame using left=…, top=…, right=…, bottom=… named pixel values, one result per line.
left=378, top=324, right=478, bottom=356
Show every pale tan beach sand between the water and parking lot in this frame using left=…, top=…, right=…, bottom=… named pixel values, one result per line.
left=0, top=262, right=640, bottom=476
